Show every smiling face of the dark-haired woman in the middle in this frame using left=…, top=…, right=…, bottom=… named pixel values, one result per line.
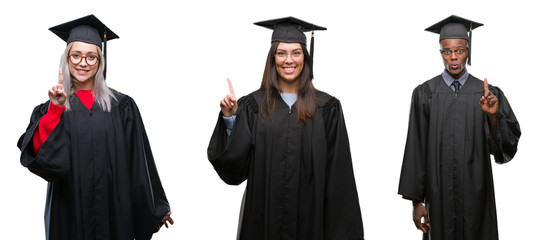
left=275, top=42, right=304, bottom=82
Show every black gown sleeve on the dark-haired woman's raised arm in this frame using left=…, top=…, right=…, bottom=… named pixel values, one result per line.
left=207, top=95, right=258, bottom=185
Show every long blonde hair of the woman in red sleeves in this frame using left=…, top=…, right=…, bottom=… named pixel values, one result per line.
left=60, top=42, right=116, bottom=112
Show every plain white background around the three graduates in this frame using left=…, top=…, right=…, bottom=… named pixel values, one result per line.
left=0, top=0, right=538, bottom=240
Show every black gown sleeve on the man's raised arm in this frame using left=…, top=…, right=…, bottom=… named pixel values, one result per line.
left=485, top=86, right=521, bottom=164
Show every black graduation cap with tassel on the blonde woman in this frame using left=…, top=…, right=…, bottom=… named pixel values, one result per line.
left=49, top=14, right=119, bottom=78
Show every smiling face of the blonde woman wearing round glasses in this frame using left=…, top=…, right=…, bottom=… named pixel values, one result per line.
left=67, top=42, right=100, bottom=89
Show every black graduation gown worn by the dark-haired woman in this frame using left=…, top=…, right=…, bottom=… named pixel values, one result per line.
left=208, top=91, right=363, bottom=240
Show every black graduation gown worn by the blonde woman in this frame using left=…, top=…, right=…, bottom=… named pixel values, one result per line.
left=18, top=92, right=170, bottom=240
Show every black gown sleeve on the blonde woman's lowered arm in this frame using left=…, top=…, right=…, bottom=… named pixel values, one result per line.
left=120, top=97, right=170, bottom=239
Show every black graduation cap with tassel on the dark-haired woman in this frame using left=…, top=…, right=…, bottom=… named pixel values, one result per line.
left=254, top=17, right=327, bottom=79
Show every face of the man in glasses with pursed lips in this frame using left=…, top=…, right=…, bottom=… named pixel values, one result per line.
left=441, top=39, right=469, bottom=79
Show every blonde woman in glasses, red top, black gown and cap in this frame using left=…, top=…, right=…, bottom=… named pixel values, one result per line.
left=18, top=15, right=174, bottom=240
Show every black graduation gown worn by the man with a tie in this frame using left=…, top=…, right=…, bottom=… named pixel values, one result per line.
left=398, top=75, right=521, bottom=240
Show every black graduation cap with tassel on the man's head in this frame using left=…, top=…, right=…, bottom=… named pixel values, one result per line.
left=425, top=15, right=484, bottom=65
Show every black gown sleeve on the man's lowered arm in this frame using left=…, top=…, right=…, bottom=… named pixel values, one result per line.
left=398, top=83, right=430, bottom=202
